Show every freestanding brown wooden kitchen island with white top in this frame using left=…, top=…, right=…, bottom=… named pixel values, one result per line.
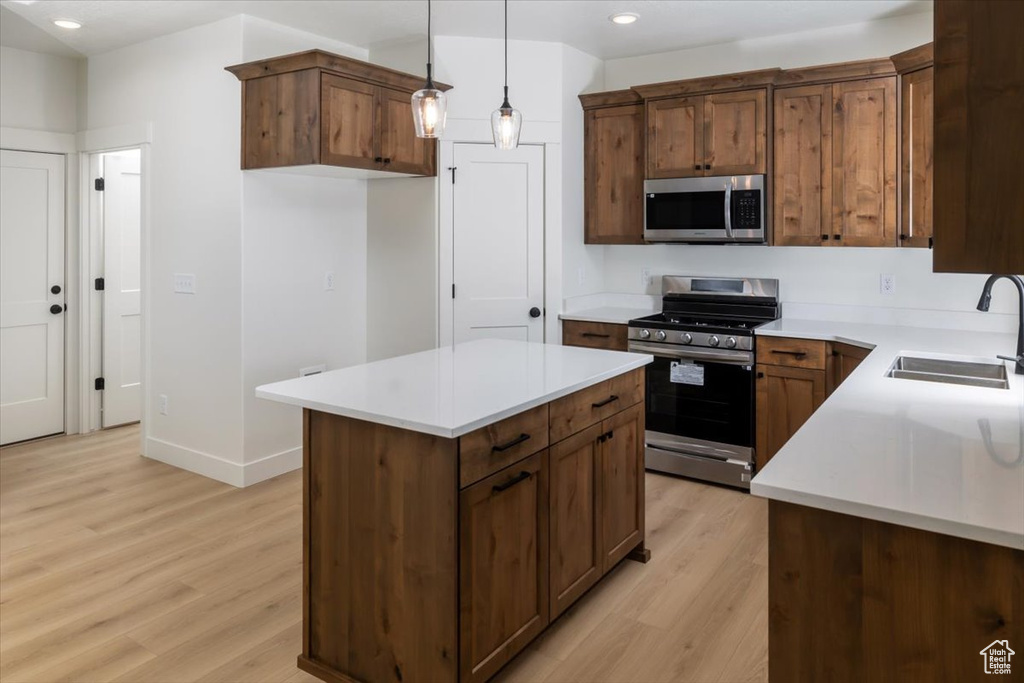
left=256, top=340, right=651, bottom=683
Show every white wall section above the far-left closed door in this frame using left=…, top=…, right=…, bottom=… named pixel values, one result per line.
left=0, top=47, right=79, bottom=133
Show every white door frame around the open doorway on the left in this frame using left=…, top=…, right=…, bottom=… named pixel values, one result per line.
left=79, top=124, right=153, bottom=448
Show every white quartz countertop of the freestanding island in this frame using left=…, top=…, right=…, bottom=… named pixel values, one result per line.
left=256, top=339, right=653, bottom=438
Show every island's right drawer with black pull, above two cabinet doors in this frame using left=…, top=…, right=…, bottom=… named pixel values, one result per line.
left=550, top=368, right=644, bottom=443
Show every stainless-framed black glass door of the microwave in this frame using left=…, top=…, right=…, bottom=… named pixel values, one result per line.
left=643, top=176, right=732, bottom=242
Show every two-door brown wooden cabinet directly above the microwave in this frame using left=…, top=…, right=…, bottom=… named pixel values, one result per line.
left=647, top=89, right=768, bottom=178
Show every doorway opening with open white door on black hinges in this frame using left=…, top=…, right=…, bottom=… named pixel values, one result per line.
left=83, top=147, right=143, bottom=429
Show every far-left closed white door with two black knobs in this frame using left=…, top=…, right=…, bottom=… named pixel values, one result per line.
left=0, top=150, right=65, bottom=443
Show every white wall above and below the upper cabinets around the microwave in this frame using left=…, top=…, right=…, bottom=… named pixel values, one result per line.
left=589, top=13, right=1014, bottom=328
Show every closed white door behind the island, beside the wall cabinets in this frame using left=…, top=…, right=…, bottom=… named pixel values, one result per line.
left=452, top=144, right=544, bottom=344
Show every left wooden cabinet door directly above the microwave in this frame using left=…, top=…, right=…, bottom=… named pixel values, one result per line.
left=647, top=95, right=705, bottom=178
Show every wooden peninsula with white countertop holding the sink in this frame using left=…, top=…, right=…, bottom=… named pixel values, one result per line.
left=751, top=318, right=1024, bottom=683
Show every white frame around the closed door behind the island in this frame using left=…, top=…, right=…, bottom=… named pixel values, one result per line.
left=437, top=137, right=562, bottom=346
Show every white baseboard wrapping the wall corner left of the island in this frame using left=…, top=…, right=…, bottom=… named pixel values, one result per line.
left=143, top=436, right=302, bottom=488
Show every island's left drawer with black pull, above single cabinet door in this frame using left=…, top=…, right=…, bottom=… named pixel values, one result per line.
left=459, top=405, right=548, bottom=488
